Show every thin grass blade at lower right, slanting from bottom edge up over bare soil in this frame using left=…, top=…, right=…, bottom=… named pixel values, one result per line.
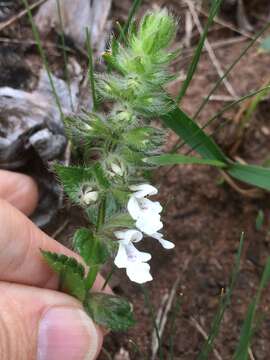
left=197, top=233, right=244, bottom=360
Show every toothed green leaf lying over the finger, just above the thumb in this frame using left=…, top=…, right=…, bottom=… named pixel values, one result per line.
left=41, top=250, right=86, bottom=301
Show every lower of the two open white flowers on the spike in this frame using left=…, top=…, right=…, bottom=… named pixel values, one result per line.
left=114, top=230, right=153, bottom=284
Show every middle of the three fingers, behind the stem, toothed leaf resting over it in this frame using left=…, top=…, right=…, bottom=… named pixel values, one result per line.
left=0, top=199, right=108, bottom=290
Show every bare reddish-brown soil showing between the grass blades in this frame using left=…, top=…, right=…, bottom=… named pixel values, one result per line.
left=3, top=0, right=270, bottom=360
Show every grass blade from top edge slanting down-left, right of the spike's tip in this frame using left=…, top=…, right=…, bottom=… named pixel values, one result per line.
left=175, top=0, right=222, bottom=103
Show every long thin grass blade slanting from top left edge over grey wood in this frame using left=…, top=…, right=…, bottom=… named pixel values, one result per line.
left=22, top=0, right=64, bottom=120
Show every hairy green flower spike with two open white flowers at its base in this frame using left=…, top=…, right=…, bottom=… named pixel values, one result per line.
left=62, top=9, right=176, bottom=283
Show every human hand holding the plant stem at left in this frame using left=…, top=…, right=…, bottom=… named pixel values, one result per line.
left=0, top=170, right=106, bottom=360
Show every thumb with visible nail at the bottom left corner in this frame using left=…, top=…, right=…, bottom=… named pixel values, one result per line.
left=0, top=282, right=103, bottom=360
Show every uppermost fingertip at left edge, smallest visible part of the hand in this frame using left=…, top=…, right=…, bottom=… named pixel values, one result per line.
left=0, top=170, right=38, bottom=215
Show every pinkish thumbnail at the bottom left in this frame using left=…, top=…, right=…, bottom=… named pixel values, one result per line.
left=37, top=307, right=102, bottom=360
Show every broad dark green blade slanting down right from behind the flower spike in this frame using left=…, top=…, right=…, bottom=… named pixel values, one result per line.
left=161, top=107, right=228, bottom=163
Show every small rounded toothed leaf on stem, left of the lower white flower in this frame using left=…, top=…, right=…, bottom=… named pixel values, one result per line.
left=73, top=228, right=108, bottom=266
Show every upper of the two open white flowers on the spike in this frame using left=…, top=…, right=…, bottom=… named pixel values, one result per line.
left=127, top=184, right=163, bottom=236
